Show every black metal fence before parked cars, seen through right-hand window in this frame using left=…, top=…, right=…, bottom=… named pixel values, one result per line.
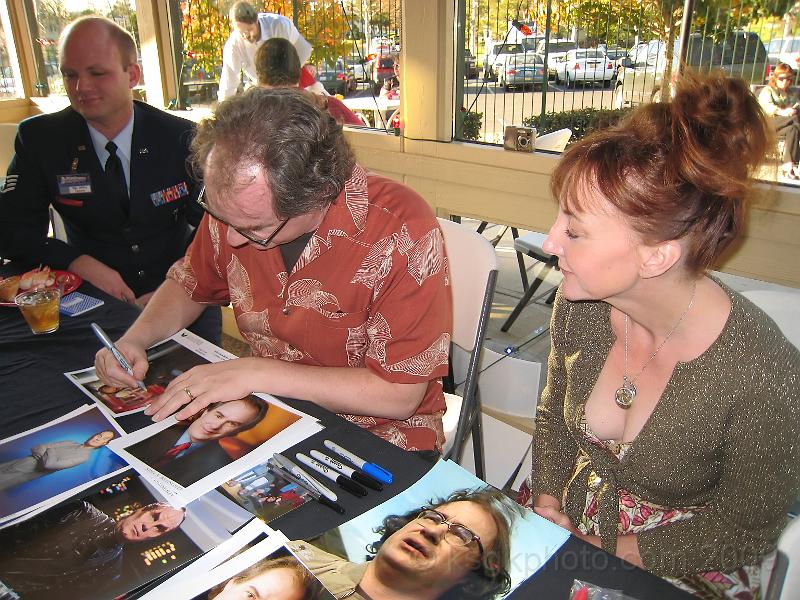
left=455, top=0, right=800, bottom=157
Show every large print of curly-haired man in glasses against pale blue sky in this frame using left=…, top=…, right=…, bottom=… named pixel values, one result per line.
left=287, top=461, right=569, bottom=600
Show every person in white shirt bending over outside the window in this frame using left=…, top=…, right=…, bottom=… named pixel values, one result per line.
left=217, top=2, right=324, bottom=102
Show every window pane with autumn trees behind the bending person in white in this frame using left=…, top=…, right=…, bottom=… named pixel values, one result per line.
left=173, top=0, right=402, bottom=128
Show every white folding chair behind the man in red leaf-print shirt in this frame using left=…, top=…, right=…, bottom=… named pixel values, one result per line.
left=439, top=219, right=497, bottom=479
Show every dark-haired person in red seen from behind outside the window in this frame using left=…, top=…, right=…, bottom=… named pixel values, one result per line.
left=256, top=38, right=364, bottom=126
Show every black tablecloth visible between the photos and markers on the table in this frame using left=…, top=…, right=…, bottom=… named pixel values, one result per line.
left=0, top=265, right=689, bottom=600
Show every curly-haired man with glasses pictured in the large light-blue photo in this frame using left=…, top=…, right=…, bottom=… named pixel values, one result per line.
left=288, top=488, right=517, bottom=600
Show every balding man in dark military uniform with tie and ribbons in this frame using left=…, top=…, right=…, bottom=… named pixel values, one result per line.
left=0, top=17, right=221, bottom=341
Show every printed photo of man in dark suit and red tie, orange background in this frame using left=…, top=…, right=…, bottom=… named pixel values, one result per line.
left=123, top=396, right=300, bottom=487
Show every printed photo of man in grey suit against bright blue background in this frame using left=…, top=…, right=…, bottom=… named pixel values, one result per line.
left=0, top=406, right=127, bottom=520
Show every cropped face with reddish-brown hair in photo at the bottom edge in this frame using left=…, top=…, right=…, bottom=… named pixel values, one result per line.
left=208, top=556, right=321, bottom=600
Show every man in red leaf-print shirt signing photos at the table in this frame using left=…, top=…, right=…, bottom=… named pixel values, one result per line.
left=95, top=88, right=452, bottom=450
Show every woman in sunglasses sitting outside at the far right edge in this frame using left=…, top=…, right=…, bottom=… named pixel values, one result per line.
left=758, top=63, right=800, bottom=181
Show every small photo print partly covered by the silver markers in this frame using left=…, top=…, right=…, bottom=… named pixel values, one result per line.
left=219, top=464, right=311, bottom=523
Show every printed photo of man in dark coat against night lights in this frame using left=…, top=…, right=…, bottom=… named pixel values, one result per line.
left=0, top=471, right=247, bottom=600
